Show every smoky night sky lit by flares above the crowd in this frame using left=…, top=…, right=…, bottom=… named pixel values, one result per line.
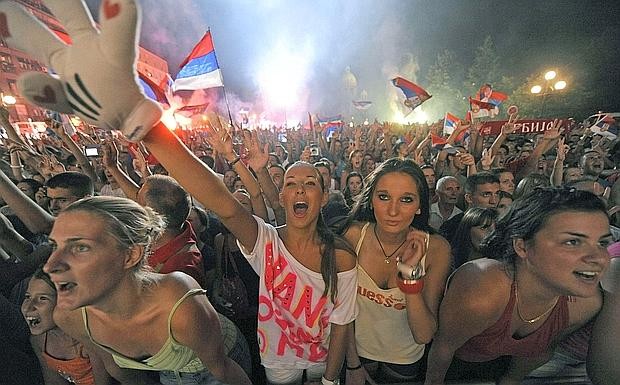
left=88, top=0, right=620, bottom=120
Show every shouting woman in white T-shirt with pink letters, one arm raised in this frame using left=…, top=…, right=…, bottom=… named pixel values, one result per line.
left=145, top=122, right=357, bottom=385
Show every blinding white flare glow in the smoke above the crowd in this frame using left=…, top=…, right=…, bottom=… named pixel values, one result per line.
left=257, top=44, right=310, bottom=109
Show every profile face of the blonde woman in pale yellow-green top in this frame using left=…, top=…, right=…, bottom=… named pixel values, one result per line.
left=43, top=210, right=129, bottom=310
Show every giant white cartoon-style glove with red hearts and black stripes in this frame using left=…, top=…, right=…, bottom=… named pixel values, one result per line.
left=0, top=0, right=162, bottom=141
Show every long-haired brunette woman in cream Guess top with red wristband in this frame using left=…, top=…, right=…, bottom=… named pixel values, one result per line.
left=344, top=158, right=450, bottom=385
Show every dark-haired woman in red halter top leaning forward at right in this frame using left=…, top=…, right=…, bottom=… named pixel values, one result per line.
left=425, top=188, right=611, bottom=385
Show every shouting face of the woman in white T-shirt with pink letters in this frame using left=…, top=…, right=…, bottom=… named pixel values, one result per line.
left=280, top=163, right=328, bottom=227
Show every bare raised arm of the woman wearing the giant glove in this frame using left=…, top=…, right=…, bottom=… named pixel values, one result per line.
left=144, top=119, right=258, bottom=250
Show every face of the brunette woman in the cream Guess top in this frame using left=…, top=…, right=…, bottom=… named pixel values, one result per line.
left=372, top=172, right=420, bottom=233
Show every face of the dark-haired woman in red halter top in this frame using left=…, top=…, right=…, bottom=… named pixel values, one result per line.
left=521, top=211, right=612, bottom=297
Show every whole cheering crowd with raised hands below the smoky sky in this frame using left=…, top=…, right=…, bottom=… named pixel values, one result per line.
left=0, top=1, right=620, bottom=385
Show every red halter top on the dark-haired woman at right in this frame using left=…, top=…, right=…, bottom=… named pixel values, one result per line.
left=455, top=282, right=568, bottom=362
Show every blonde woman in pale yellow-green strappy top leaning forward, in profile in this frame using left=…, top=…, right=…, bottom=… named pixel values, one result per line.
left=43, top=197, right=251, bottom=385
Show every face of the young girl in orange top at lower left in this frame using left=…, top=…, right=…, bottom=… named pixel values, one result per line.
left=21, top=278, right=56, bottom=335
